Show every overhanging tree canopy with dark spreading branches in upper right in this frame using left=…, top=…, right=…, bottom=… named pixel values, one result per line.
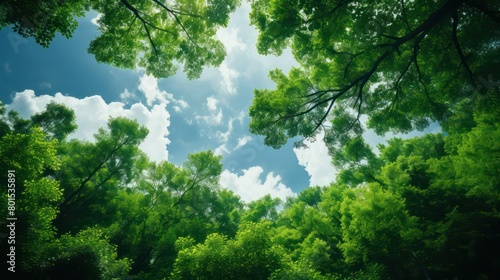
left=249, top=0, right=500, bottom=147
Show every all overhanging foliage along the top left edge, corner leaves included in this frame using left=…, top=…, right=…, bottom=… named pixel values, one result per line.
left=0, top=0, right=241, bottom=79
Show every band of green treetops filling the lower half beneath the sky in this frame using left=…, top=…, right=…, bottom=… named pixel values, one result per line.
left=0, top=95, right=500, bottom=279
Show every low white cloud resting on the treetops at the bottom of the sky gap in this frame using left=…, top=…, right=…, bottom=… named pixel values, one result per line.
left=219, top=166, right=296, bottom=202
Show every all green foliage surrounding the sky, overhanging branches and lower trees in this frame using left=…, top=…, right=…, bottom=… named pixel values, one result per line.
left=0, top=0, right=500, bottom=280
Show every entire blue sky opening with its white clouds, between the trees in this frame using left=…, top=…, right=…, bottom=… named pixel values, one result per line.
left=0, top=3, right=335, bottom=201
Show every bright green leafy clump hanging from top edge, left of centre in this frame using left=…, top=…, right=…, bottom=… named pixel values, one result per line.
left=88, top=0, right=240, bottom=79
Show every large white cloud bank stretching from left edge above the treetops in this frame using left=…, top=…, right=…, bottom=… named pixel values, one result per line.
left=7, top=90, right=170, bottom=161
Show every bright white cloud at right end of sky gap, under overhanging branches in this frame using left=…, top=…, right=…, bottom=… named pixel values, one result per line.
left=293, top=132, right=337, bottom=186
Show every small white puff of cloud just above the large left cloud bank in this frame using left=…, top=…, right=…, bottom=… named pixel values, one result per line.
left=139, top=74, right=189, bottom=108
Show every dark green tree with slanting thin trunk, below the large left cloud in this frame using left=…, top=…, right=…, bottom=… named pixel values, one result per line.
left=55, top=118, right=148, bottom=233
